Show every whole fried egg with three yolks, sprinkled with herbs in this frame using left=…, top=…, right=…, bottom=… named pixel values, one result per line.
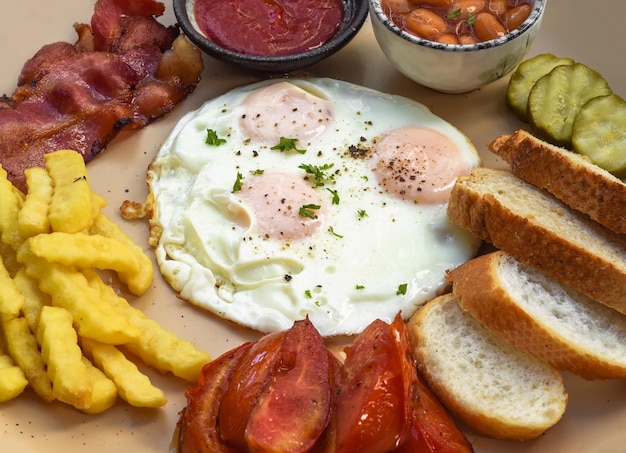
left=148, top=78, right=480, bottom=336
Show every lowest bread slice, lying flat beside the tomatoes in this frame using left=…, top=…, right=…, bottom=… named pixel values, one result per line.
left=408, top=294, right=567, bottom=440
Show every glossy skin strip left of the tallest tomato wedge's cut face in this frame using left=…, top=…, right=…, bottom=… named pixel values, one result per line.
left=218, top=331, right=286, bottom=451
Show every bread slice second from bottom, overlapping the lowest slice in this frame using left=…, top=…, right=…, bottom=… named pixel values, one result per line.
left=448, top=251, right=626, bottom=379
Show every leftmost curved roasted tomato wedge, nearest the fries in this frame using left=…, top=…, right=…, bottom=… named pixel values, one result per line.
left=177, top=343, right=252, bottom=453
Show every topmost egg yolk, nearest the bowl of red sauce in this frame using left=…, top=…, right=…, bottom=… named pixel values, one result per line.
left=239, top=82, right=332, bottom=145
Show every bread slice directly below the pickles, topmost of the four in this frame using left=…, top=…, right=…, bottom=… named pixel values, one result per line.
left=488, top=130, right=626, bottom=233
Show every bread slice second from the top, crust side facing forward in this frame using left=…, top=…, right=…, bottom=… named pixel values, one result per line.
left=448, top=167, right=626, bottom=313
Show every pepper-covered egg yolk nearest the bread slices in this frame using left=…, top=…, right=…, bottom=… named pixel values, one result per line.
left=372, top=127, right=470, bottom=204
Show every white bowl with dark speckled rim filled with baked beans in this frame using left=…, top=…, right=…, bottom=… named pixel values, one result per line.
left=369, top=0, right=547, bottom=93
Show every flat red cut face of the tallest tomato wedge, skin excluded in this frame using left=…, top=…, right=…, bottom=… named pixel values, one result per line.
left=245, top=319, right=333, bottom=453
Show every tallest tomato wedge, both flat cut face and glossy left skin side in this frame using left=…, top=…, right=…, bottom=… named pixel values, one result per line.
left=219, top=319, right=332, bottom=453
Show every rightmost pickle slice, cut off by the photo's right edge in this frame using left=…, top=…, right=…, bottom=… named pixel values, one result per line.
left=572, top=94, right=626, bottom=178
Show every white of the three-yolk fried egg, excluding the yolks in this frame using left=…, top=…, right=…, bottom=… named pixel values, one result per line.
left=148, top=78, right=480, bottom=336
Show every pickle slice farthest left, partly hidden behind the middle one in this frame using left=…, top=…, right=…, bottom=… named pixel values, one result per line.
left=506, top=53, right=574, bottom=122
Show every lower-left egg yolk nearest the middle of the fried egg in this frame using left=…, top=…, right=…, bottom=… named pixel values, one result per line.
left=239, top=173, right=326, bottom=240
